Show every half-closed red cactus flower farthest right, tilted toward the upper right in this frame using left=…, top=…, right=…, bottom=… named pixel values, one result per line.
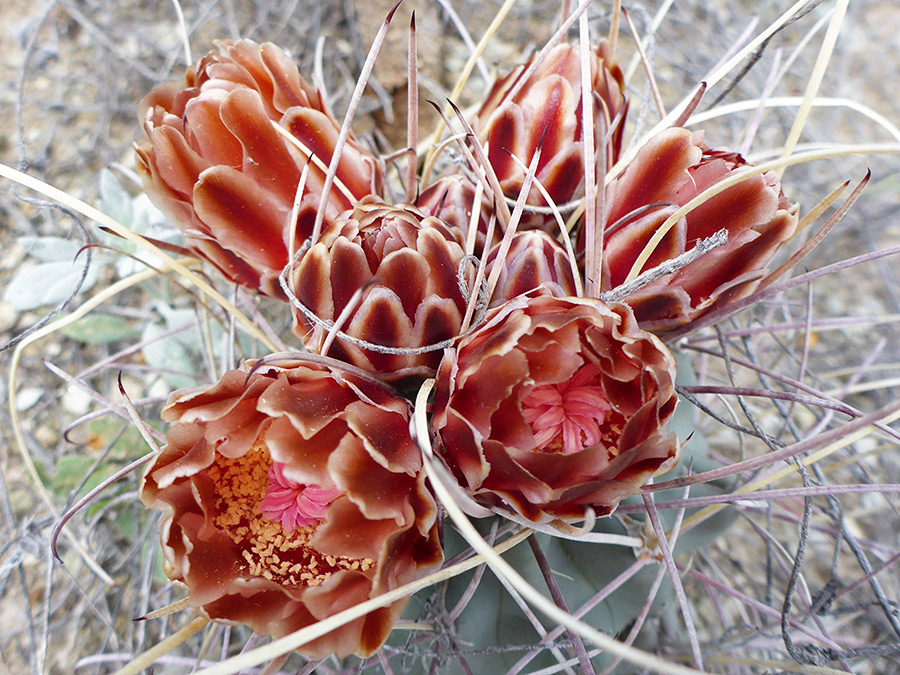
left=602, top=128, right=798, bottom=333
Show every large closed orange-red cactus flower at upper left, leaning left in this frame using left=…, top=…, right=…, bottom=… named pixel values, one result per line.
left=135, top=40, right=381, bottom=297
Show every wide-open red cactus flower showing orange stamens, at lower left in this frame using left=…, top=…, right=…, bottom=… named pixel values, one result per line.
left=141, top=359, right=441, bottom=657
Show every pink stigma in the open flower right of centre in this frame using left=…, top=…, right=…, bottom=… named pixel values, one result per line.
left=522, top=364, right=615, bottom=455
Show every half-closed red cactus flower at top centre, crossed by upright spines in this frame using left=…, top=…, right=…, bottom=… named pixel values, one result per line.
left=475, top=41, right=627, bottom=233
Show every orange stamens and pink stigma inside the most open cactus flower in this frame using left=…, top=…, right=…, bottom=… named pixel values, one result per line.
left=206, top=439, right=375, bottom=587
